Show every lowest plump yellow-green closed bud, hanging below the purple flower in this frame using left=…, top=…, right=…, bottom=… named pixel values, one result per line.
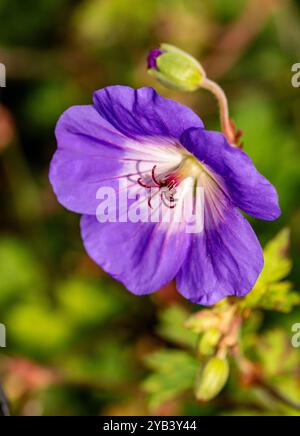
left=195, top=357, right=229, bottom=401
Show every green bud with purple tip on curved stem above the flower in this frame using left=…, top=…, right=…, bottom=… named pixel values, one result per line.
left=148, top=44, right=206, bottom=91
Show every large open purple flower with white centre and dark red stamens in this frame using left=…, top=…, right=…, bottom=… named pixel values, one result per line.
left=50, top=86, right=280, bottom=305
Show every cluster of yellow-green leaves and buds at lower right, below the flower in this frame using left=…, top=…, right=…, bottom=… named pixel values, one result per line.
left=144, top=229, right=300, bottom=415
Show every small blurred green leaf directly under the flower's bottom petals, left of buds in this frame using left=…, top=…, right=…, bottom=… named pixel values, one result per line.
left=158, top=305, right=198, bottom=348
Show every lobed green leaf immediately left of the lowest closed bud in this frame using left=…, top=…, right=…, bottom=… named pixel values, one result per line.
left=143, top=350, right=198, bottom=408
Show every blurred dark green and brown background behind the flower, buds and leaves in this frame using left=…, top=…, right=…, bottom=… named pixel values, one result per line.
left=0, top=0, right=300, bottom=415
